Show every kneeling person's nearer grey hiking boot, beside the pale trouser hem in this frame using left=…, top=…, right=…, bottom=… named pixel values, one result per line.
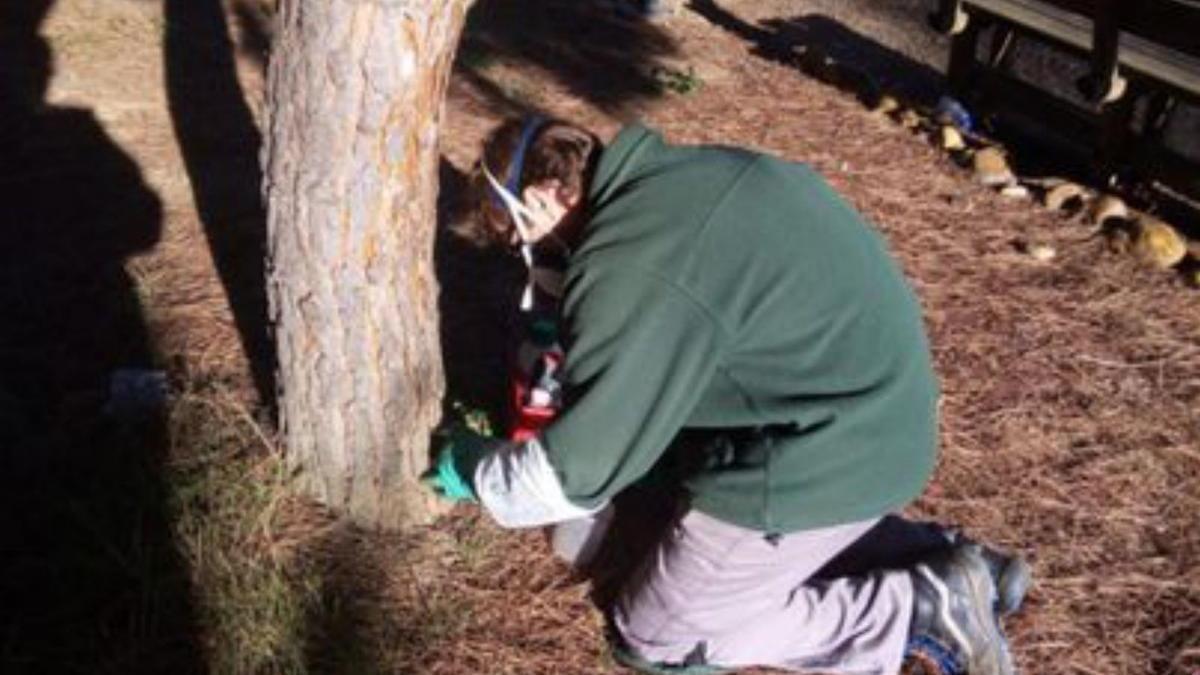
left=906, top=543, right=1015, bottom=675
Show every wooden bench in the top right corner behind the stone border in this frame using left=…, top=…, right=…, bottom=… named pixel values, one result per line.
left=934, top=0, right=1200, bottom=197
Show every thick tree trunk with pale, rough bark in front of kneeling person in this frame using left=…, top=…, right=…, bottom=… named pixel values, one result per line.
left=263, top=0, right=467, bottom=527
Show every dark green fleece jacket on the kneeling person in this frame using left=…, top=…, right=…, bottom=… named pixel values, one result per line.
left=542, top=126, right=937, bottom=533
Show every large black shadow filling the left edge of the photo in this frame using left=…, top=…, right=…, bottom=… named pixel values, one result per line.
left=0, top=0, right=206, bottom=674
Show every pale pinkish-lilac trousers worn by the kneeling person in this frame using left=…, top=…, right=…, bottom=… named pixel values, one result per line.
left=613, top=510, right=912, bottom=675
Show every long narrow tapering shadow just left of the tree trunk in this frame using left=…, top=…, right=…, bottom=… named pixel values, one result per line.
left=163, top=0, right=276, bottom=419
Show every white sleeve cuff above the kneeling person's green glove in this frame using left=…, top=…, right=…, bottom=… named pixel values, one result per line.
left=475, top=437, right=605, bottom=527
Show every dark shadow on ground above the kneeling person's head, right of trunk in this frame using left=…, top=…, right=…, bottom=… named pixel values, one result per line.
left=455, top=0, right=678, bottom=113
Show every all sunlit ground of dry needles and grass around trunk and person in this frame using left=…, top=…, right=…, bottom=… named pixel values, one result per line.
left=25, top=0, right=1200, bottom=675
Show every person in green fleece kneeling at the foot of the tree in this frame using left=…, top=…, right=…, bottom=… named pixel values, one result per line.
left=427, top=118, right=1028, bottom=675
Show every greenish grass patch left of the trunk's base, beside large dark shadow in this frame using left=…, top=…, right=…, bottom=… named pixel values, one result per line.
left=168, top=392, right=318, bottom=673
